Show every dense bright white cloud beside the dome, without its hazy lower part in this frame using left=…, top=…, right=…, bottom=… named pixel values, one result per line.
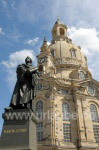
left=68, top=27, right=99, bottom=54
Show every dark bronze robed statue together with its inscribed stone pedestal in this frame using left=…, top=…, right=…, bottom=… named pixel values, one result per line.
left=0, top=57, right=38, bottom=150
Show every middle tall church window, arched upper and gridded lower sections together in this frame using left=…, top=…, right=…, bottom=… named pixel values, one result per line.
left=62, top=103, right=71, bottom=142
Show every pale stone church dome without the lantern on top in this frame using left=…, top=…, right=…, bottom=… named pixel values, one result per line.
left=50, top=40, right=87, bottom=68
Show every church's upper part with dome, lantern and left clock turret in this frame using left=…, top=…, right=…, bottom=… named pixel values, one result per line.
left=37, top=18, right=91, bottom=80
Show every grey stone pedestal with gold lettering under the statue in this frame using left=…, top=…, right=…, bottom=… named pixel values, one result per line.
left=0, top=109, right=38, bottom=150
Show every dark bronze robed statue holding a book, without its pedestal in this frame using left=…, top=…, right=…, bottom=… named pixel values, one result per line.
left=5, top=57, right=38, bottom=111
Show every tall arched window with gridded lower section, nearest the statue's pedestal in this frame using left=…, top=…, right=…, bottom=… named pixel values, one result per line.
left=36, top=101, right=43, bottom=141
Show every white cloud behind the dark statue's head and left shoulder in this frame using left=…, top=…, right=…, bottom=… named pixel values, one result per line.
left=2, top=49, right=36, bottom=91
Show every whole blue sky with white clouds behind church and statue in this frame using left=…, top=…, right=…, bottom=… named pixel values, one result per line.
left=0, top=0, right=99, bottom=130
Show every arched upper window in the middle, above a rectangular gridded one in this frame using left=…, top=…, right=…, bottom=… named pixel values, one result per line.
left=62, top=103, right=70, bottom=121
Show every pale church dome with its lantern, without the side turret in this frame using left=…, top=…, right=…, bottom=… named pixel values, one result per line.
left=49, top=18, right=87, bottom=68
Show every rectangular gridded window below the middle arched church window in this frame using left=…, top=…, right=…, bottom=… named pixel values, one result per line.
left=63, top=123, right=71, bottom=142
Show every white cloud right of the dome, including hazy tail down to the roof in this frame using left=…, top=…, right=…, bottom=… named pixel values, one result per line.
left=68, top=27, right=99, bottom=80
